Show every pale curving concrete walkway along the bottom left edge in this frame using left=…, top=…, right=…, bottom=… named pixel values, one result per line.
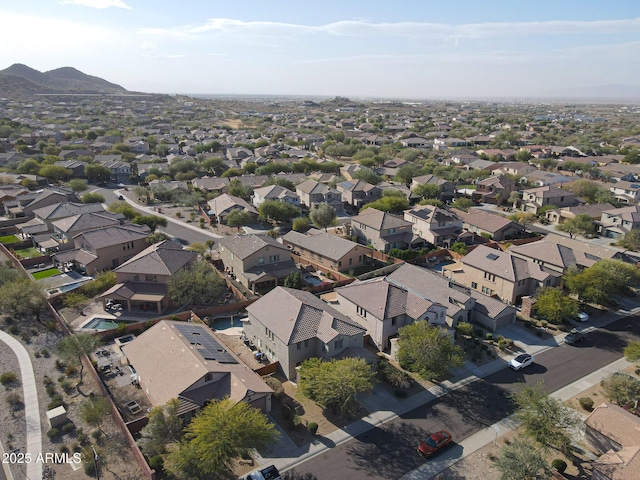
left=0, top=330, right=42, bottom=479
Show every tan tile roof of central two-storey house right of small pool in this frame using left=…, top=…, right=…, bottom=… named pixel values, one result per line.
left=247, top=287, right=365, bottom=345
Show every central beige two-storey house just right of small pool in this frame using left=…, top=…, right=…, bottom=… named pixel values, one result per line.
left=244, top=287, right=370, bottom=380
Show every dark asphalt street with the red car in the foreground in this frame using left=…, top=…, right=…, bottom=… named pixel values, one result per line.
left=284, top=317, right=640, bottom=480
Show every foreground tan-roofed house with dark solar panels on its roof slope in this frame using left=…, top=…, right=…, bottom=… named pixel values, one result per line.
left=122, top=320, right=273, bottom=421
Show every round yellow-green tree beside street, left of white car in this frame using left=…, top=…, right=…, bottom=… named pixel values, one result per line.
left=398, top=320, right=465, bottom=380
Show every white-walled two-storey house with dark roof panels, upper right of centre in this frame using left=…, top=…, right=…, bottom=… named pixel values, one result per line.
left=404, top=205, right=462, bottom=247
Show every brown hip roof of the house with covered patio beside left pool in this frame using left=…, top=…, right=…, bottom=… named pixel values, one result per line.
left=114, top=240, right=198, bottom=275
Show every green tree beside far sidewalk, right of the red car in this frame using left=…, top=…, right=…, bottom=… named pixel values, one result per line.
left=511, top=382, right=582, bottom=453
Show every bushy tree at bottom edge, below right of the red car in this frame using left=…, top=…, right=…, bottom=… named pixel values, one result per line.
left=493, top=437, right=551, bottom=480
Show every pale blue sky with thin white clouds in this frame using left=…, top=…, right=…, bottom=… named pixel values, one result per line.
left=0, top=0, right=640, bottom=98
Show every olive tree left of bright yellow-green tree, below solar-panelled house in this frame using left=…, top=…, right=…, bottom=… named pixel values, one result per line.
left=137, top=398, right=184, bottom=457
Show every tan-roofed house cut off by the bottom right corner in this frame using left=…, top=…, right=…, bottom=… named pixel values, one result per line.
left=585, top=403, right=640, bottom=480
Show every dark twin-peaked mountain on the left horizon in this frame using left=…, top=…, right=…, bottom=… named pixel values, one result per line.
left=0, top=63, right=128, bottom=97
